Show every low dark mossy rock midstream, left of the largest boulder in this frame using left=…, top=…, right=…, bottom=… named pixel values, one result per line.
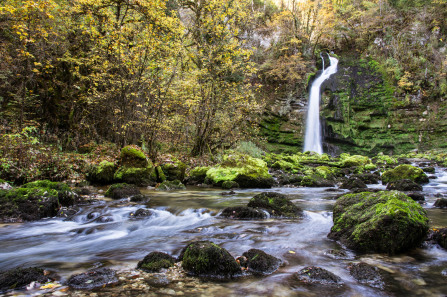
left=247, top=192, right=303, bottom=218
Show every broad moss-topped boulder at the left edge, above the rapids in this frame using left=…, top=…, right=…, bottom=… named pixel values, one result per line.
left=0, top=180, right=77, bottom=222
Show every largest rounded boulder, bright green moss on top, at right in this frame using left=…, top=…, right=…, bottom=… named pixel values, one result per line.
left=328, top=191, right=428, bottom=254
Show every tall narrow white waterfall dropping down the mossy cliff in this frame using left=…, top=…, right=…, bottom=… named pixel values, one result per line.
left=304, top=56, right=338, bottom=154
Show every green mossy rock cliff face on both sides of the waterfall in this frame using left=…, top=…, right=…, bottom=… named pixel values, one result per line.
left=261, top=57, right=447, bottom=154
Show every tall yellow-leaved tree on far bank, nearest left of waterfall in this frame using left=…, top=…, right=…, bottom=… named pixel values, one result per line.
left=180, top=0, right=258, bottom=156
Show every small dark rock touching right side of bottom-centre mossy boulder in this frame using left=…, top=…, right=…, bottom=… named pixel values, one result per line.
left=239, top=249, right=281, bottom=275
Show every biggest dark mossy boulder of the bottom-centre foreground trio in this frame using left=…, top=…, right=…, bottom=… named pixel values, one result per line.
left=179, top=241, right=241, bottom=279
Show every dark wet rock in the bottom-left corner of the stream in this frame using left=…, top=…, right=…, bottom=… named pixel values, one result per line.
left=0, top=267, right=48, bottom=292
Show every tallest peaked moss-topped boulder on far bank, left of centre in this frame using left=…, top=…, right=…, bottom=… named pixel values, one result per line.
left=113, top=145, right=157, bottom=186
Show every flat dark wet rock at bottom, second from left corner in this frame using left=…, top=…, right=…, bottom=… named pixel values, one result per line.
left=67, top=268, right=118, bottom=290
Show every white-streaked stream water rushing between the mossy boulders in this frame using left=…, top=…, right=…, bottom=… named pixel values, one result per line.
left=0, top=172, right=447, bottom=296
